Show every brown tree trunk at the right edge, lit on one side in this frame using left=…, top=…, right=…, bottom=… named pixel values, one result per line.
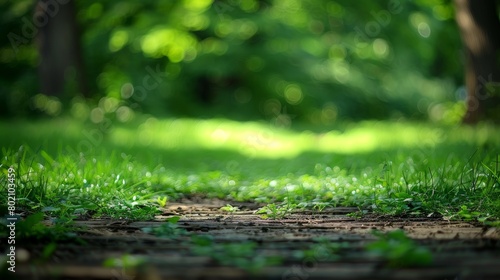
left=455, top=0, right=500, bottom=124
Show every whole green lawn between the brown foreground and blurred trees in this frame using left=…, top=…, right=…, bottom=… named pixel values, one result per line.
left=0, top=117, right=500, bottom=223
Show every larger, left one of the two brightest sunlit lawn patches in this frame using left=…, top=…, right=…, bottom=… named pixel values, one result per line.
left=110, top=119, right=307, bottom=158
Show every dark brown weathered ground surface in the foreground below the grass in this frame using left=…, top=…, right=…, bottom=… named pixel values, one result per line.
left=6, top=199, right=500, bottom=280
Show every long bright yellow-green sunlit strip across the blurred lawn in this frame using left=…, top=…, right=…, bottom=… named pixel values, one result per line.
left=103, top=118, right=498, bottom=158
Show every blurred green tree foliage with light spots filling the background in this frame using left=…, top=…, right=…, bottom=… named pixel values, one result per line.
left=0, top=0, right=472, bottom=126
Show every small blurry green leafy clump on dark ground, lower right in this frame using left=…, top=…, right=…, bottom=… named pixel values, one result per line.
left=366, top=230, right=433, bottom=268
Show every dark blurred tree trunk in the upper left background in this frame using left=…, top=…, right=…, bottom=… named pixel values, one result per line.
left=33, top=0, right=87, bottom=97
